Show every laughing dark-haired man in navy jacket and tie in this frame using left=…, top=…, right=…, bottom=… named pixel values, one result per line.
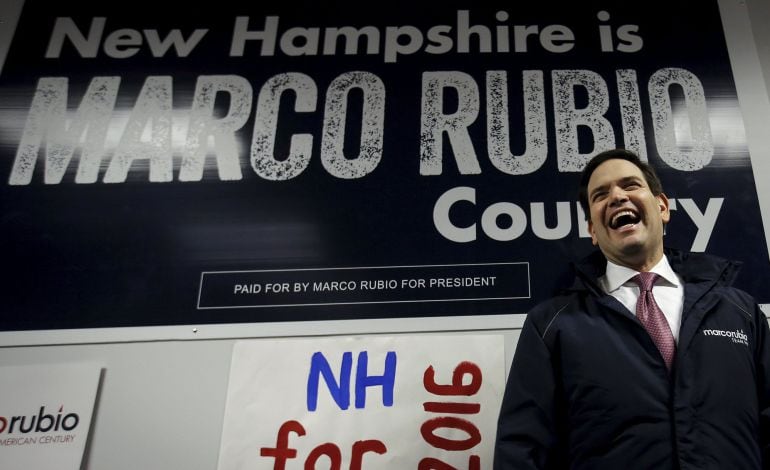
left=494, top=149, right=770, bottom=470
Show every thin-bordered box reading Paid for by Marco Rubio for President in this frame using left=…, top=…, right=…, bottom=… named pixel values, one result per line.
left=198, top=262, right=531, bottom=309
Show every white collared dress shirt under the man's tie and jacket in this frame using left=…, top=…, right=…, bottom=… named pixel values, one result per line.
left=599, top=255, right=684, bottom=344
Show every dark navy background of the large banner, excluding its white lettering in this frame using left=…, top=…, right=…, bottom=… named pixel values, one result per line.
left=0, top=0, right=770, bottom=331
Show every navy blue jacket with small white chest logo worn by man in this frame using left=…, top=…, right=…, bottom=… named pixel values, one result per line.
left=494, top=250, right=770, bottom=470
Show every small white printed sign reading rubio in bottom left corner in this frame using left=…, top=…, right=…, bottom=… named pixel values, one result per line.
left=0, top=364, right=102, bottom=470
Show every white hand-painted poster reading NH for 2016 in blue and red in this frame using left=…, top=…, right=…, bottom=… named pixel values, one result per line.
left=217, top=335, right=505, bottom=470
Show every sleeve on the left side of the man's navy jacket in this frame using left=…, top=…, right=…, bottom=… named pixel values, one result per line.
left=494, top=315, right=565, bottom=470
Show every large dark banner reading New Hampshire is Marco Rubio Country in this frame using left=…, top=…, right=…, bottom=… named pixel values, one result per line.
left=0, top=0, right=770, bottom=331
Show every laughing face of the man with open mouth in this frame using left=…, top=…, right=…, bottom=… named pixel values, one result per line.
left=588, top=159, right=671, bottom=271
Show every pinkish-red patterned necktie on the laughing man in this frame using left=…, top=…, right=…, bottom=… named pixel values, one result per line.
left=631, top=272, right=676, bottom=370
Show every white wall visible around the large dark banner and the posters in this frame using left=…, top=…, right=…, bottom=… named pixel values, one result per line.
left=0, top=0, right=770, bottom=470
